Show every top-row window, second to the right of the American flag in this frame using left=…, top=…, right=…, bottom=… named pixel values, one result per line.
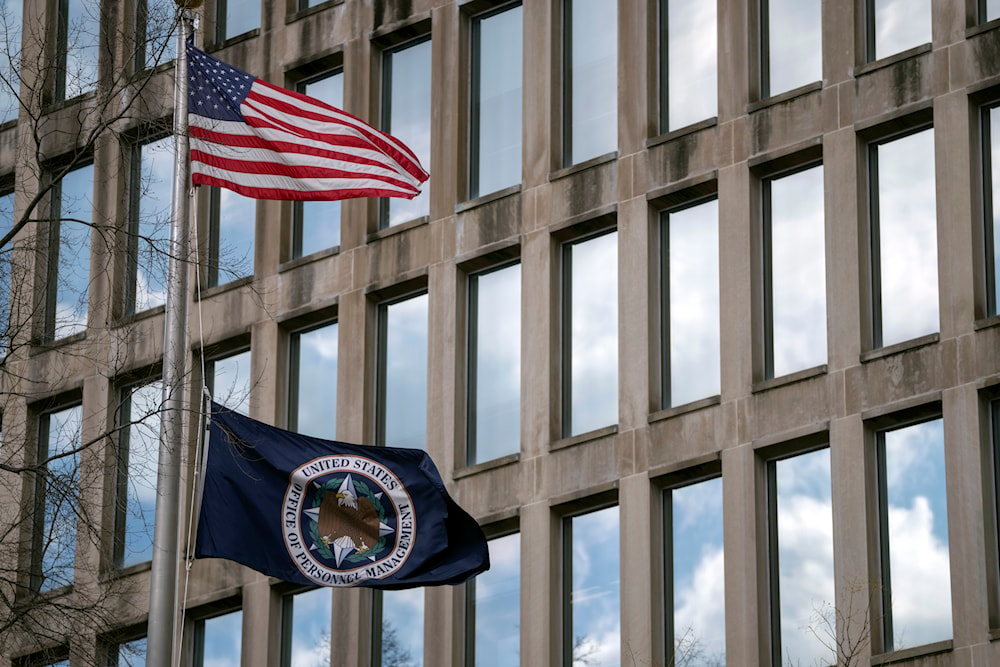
left=563, top=0, right=618, bottom=166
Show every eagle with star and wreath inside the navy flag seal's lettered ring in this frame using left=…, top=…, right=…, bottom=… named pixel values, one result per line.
left=304, top=474, right=394, bottom=567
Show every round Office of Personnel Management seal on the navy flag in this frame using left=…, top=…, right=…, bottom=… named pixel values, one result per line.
left=282, top=455, right=416, bottom=586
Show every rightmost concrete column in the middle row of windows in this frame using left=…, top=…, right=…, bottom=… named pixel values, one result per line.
left=934, top=88, right=981, bottom=340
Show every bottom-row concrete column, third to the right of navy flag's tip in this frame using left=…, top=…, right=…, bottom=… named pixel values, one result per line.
left=722, top=443, right=761, bottom=666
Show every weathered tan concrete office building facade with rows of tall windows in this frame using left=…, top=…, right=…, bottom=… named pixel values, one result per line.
left=0, top=0, right=1000, bottom=667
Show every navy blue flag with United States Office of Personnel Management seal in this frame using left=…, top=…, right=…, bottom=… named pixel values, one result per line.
left=195, top=403, right=490, bottom=589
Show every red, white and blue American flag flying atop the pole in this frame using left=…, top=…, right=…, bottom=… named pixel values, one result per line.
left=187, top=42, right=428, bottom=200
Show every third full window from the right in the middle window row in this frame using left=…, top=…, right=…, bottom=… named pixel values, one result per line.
left=660, top=199, right=722, bottom=408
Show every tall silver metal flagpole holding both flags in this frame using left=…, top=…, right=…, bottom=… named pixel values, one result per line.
left=146, top=6, right=195, bottom=667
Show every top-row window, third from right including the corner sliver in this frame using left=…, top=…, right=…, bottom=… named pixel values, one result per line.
left=760, top=0, right=823, bottom=97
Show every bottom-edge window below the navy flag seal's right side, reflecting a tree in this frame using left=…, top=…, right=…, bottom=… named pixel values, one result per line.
left=372, top=588, right=424, bottom=667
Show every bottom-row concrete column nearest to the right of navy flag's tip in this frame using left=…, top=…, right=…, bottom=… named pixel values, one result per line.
left=521, top=501, right=562, bottom=665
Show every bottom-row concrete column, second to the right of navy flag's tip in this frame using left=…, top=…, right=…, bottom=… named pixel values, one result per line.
left=618, top=473, right=663, bottom=665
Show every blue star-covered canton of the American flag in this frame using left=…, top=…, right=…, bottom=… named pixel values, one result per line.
left=187, top=42, right=257, bottom=123
